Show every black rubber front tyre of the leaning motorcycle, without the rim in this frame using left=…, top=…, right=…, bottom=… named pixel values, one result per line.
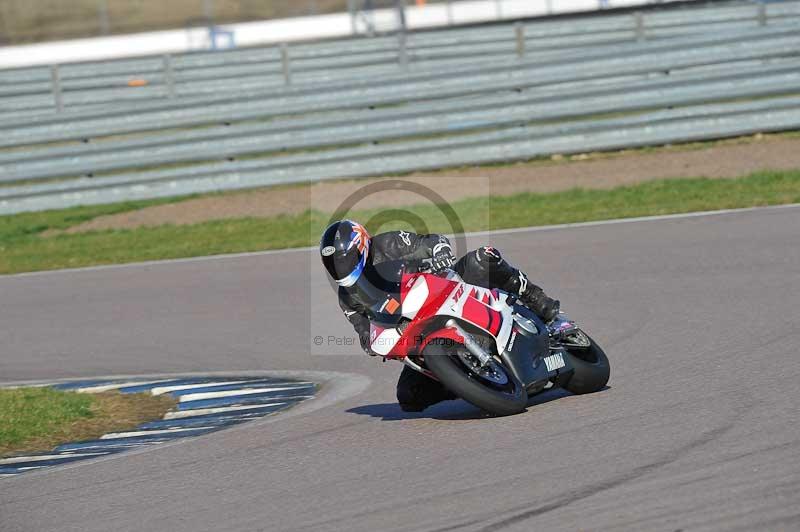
left=423, top=342, right=528, bottom=416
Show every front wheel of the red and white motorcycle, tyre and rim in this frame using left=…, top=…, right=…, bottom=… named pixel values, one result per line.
left=423, top=343, right=528, bottom=416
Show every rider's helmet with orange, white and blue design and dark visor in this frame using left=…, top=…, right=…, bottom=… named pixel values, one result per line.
left=319, top=220, right=370, bottom=287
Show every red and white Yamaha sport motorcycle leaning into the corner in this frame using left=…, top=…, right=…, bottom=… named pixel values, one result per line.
left=369, top=264, right=610, bottom=415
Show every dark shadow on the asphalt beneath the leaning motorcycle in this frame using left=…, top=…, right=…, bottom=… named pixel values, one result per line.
left=347, top=388, right=572, bottom=421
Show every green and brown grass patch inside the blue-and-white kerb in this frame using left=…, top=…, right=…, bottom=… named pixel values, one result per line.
left=0, top=387, right=175, bottom=457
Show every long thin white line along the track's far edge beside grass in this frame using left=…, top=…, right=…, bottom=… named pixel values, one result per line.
left=0, top=203, right=800, bottom=281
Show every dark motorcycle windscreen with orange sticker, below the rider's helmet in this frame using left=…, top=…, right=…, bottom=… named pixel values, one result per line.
left=351, top=260, right=404, bottom=325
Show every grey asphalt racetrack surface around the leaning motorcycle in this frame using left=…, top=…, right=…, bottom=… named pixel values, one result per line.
left=0, top=207, right=800, bottom=532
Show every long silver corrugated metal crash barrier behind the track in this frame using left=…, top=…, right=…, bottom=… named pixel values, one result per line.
left=0, top=3, right=800, bottom=213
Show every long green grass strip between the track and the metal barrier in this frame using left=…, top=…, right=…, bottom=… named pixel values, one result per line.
left=0, top=170, right=800, bottom=273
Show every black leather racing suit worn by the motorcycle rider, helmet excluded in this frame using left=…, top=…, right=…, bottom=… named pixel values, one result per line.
left=339, top=231, right=558, bottom=411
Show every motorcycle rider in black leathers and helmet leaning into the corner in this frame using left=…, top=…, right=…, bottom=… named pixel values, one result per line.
left=319, top=220, right=560, bottom=412
